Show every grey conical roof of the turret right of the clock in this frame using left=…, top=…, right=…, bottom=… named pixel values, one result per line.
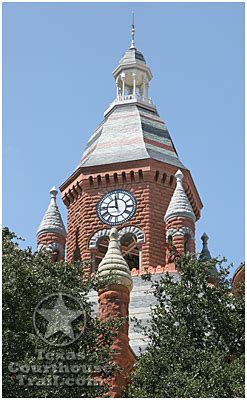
left=165, top=170, right=196, bottom=222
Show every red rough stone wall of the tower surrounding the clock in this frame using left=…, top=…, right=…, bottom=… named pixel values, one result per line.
left=61, top=160, right=200, bottom=272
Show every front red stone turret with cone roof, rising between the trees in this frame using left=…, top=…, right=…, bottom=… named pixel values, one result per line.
left=97, top=228, right=135, bottom=397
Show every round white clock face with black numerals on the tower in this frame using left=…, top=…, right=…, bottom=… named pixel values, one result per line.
left=97, top=189, right=136, bottom=225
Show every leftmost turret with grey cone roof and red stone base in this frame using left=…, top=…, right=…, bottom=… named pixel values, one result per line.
left=37, top=186, right=67, bottom=261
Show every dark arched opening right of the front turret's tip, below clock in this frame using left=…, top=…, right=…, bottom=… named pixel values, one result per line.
left=120, top=232, right=140, bottom=270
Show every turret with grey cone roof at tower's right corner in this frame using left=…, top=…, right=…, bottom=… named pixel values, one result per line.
left=164, top=170, right=196, bottom=272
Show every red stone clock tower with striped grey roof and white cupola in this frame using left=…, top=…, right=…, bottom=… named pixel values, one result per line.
left=60, top=25, right=202, bottom=276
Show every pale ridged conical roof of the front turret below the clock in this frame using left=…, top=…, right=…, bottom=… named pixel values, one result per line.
left=97, top=228, right=133, bottom=290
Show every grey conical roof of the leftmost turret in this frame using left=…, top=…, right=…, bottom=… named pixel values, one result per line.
left=37, top=186, right=67, bottom=237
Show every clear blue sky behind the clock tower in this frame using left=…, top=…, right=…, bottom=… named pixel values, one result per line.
left=3, top=3, right=244, bottom=274
